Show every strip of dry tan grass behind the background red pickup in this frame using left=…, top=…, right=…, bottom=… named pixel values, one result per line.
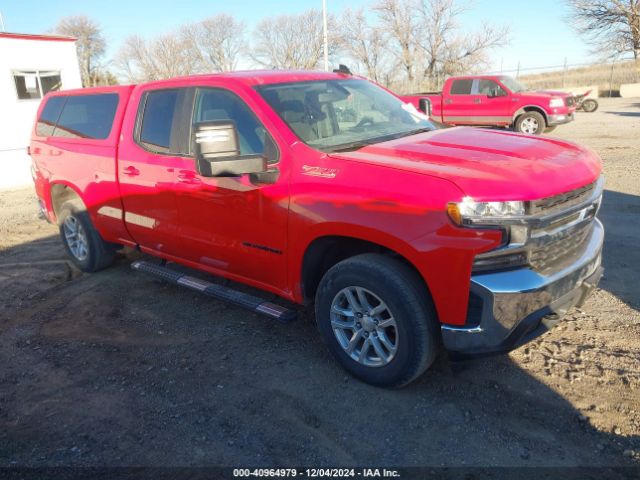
left=519, top=61, right=640, bottom=96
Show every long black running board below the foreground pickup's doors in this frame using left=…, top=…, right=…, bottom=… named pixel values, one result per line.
left=131, top=260, right=297, bottom=322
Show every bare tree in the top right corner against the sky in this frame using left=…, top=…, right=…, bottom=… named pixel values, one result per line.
left=568, top=0, right=640, bottom=68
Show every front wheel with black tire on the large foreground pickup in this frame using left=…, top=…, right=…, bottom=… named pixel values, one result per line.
left=315, top=254, right=439, bottom=387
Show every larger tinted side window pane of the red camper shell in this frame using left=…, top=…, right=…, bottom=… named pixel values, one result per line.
left=53, top=93, right=118, bottom=140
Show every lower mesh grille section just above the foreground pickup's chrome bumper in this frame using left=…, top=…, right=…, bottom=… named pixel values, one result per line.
left=529, top=221, right=593, bottom=274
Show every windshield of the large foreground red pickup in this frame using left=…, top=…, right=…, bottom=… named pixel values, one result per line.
left=257, top=79, right=435, bottom=152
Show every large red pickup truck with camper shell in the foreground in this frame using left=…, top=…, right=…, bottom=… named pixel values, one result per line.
left=29, top=71, right=604, bottom=386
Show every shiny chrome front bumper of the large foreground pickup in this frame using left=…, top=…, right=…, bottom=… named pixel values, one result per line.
left=442, top=219, right=604, bottom=355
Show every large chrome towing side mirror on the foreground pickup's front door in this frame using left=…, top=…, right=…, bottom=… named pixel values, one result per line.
left=193, top=120, right=267, bottom=177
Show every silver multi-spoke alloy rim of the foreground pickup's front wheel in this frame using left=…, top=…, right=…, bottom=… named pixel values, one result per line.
left=331, top=287, right=398, bottom=367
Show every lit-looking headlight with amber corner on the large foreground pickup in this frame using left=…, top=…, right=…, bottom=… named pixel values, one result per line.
left=447, top=197, right=525, bottom=225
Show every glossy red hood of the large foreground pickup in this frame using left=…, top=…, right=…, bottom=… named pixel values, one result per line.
left=330, top=127, right=602, bottom=201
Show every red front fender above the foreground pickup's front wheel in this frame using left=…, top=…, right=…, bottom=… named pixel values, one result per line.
left=288, top=171, right=502, bottom=325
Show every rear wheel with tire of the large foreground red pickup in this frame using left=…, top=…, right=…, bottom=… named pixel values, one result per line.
left=58, top=201, right=119, bottom=272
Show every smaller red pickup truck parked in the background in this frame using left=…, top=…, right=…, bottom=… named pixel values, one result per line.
left=402, top=75, right=576, bottom=135
